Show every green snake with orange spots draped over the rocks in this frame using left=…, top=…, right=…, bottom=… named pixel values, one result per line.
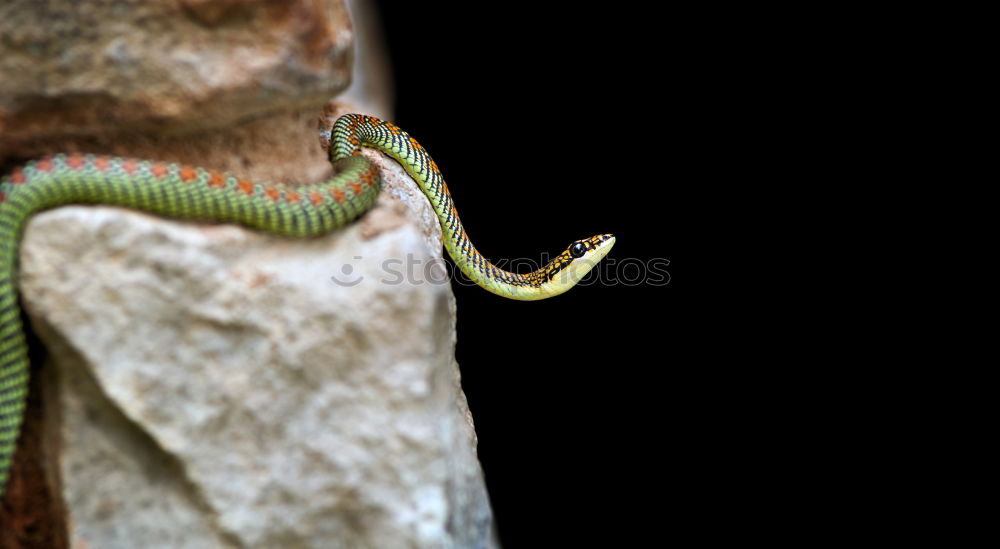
left=0, top=114, right=615, bottom=497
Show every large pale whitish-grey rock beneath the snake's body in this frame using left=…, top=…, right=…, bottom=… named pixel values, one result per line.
left=20, top=155, right=495, bottom=549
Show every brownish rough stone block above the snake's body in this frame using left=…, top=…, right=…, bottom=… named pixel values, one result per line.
left=0, top=0, right=352, bottom=151
